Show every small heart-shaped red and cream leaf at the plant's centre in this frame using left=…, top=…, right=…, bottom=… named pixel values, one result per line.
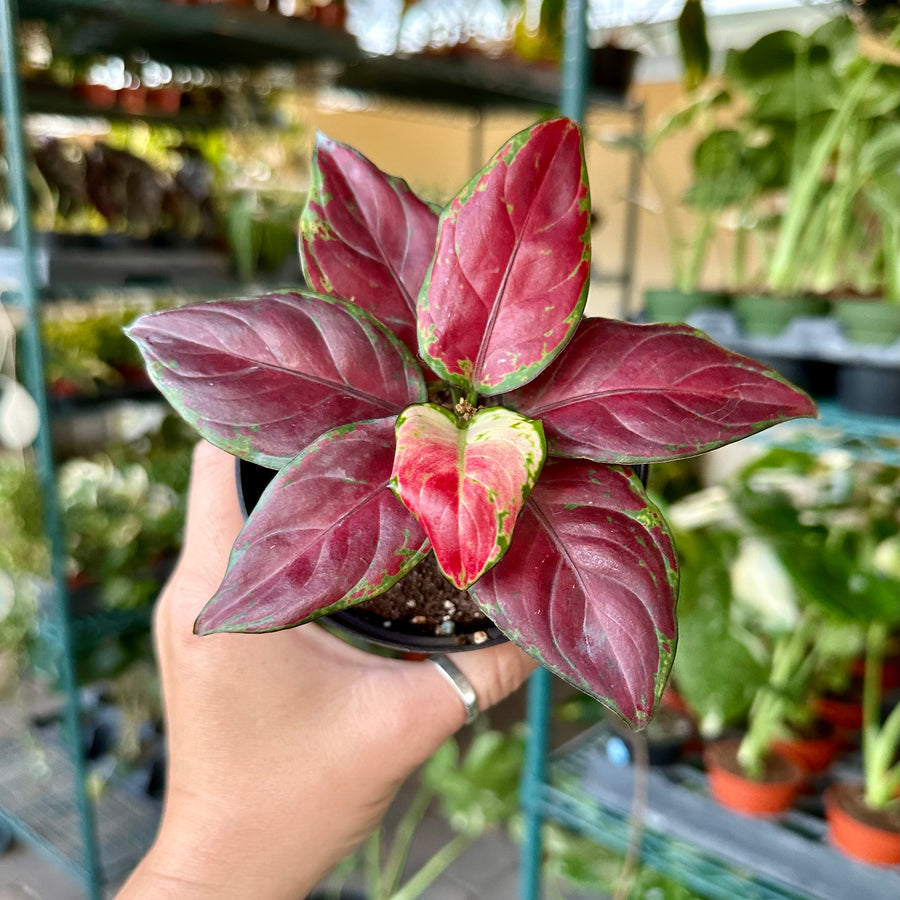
left=391, top=403, right=545, bottom=590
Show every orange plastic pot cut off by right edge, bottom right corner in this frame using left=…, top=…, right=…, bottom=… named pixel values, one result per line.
left=823, top=782, right=900, bottom=866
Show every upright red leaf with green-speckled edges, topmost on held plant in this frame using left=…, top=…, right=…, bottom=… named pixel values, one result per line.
left=418, top=119, right=590, bottom=395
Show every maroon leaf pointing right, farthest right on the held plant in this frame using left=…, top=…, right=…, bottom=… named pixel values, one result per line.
left=503, top=319, right=816, bottom=463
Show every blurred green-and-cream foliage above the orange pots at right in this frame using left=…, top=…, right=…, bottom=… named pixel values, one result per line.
left=668, top=449, right=900, bottom=733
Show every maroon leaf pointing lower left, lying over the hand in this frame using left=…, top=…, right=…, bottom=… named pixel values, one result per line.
left=194, top=418, right=429, bottom=634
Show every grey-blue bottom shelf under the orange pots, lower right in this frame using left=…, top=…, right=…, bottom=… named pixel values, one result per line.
left=540, top=724, right=900, bottom=900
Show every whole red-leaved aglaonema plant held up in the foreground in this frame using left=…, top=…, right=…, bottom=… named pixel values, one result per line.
left=129, top=118, right=815, bottom=727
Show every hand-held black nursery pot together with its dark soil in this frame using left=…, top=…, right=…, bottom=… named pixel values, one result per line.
left=236, top=460, right=507, bottom=656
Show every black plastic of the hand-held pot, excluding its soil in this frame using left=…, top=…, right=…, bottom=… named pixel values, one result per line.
left=236, top=460, right=507, bottom=655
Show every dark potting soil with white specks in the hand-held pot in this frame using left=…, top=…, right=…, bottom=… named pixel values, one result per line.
left=353, top=553, right=491, bottom=644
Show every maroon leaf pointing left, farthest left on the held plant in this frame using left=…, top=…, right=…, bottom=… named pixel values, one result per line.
left=128, top=293, right=425, bottom=468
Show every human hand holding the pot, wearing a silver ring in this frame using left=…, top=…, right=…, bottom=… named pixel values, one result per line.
left=112, top=443, right=535, bottom=900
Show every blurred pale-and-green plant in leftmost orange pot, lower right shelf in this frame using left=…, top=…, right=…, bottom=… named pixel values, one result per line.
left=672, top=492, right=816, bottom=815
